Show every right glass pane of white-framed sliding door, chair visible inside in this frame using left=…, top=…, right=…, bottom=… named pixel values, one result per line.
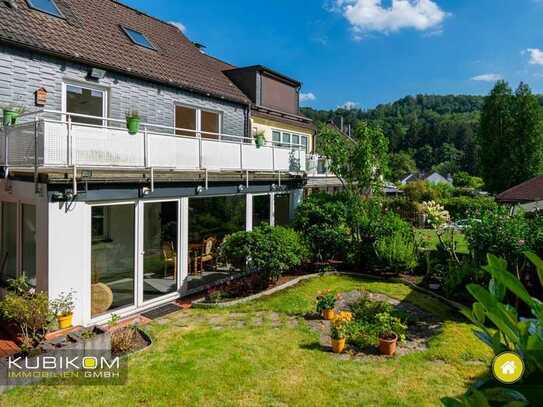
left=143, top=201, right=179, bottom=302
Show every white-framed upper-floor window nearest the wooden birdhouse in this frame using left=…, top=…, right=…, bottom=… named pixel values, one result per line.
left=65, top=84, right=107, bottom=126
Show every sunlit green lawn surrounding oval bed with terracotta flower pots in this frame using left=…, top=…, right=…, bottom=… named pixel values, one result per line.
left=0, top=276, right=491, bottom=407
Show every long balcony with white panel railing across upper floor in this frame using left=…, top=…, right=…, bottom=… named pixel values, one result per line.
left=0, top=110, right=306, bottom=172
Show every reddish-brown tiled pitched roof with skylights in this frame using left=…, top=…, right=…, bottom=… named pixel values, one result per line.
left=0, top=0, right=249, bottom=104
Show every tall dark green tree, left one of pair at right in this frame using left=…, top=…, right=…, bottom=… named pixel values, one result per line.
left=479, top=81, right=514, bottom=192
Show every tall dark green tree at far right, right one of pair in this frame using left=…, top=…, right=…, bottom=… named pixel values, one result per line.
left=511, top=83, right=543, bottom=184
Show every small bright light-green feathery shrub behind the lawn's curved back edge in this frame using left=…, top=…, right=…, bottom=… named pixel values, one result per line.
left=375, top=232, right=418, bottom=272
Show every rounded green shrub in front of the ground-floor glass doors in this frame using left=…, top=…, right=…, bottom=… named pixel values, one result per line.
left=220, top=225, right=309, bottom=284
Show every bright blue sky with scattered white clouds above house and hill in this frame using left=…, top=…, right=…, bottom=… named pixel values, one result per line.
left=125, top=0, right=543, bottom=109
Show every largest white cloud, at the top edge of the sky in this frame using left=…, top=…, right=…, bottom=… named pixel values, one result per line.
left=335, top=0, right=450, bottom=37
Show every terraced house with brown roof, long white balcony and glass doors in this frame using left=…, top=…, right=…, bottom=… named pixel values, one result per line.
left=0, top=0, right=313, bottom=325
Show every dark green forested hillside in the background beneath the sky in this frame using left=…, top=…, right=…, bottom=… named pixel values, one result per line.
left=302, top=95, right=484, bottom=177
